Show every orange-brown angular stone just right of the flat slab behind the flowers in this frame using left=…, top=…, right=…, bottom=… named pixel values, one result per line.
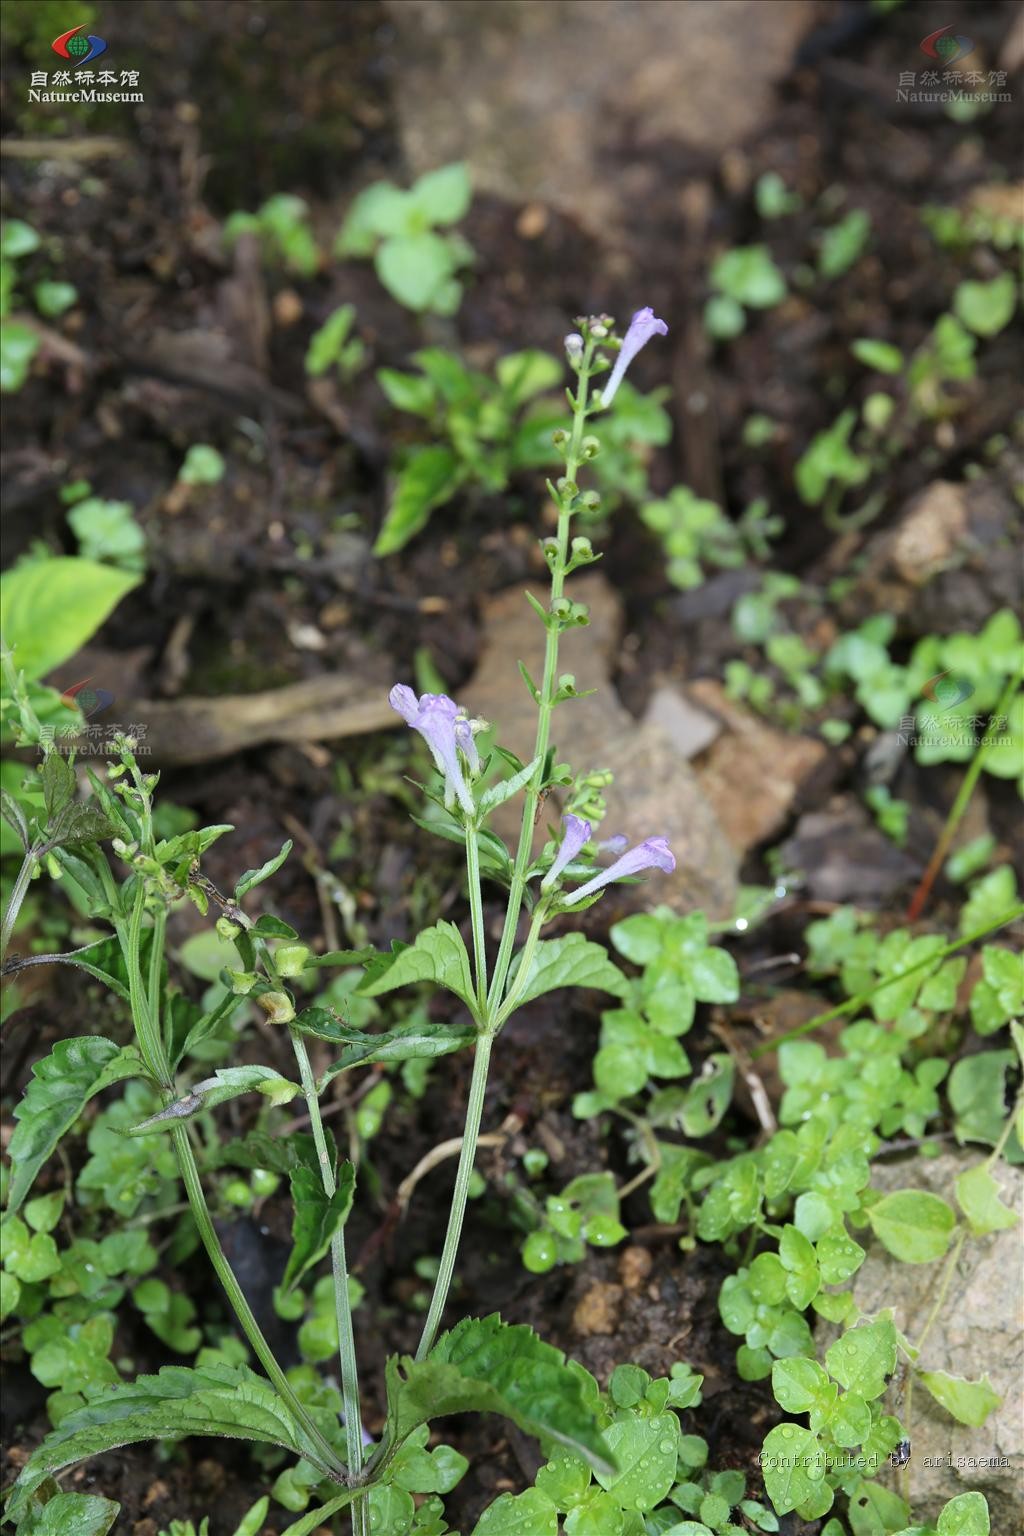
left=688, top=677, right=829, bottom=856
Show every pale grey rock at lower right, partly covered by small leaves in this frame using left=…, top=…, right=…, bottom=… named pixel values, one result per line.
left=835, top=1149, right=1024, bottom=1533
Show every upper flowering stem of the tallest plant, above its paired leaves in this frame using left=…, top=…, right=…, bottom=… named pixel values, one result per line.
left=488, top=341, right=594, bottom=1011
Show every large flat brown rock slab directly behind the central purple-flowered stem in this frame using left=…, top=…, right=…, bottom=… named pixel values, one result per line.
left=459, top=574, right=737, bottom=920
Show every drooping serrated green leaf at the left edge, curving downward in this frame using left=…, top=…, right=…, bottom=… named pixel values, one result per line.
left=8, top=1035, right=146, bottom=1213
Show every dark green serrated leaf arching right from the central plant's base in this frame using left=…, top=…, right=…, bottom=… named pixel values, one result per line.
left=387, top=1313, right=614, bottom=1473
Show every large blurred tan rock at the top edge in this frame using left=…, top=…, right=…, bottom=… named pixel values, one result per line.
left=387, top=0, right=814, bottom=235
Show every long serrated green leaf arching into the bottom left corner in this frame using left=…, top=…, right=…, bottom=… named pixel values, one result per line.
left=6, top=1366, right=327, bottom=1519
